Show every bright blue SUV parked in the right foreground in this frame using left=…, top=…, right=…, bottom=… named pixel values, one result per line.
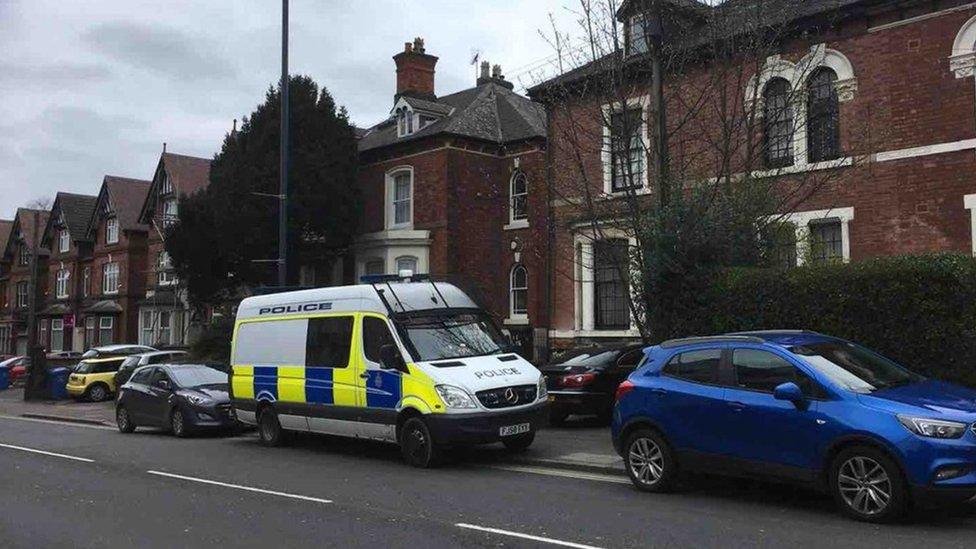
left=611, top=331, right=976, bottom=522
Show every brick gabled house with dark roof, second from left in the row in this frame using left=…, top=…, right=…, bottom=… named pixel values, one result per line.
left=38, top=193, right=97, bottom=351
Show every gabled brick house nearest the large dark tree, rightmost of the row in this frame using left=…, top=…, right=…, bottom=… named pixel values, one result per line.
left=133, top=152, right=210, bottom=348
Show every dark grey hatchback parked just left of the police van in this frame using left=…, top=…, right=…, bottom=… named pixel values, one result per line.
left=115, top=364, right=237, bottom=437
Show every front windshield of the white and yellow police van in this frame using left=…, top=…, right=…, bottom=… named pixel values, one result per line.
left=396, top=313, right=509, bottom=361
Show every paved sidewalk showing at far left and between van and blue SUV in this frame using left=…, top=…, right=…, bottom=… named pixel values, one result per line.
left=0, top=388, right=624, bottom=474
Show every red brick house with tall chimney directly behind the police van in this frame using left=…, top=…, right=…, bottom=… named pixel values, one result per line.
left=350, top=39, right=548, bottom=360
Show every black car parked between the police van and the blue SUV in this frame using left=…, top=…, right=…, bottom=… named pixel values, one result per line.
left=541, top=345, right=644, bottom=425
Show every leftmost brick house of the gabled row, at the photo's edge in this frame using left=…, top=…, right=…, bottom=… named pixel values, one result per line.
left=0, top=208, right=48, bottom=355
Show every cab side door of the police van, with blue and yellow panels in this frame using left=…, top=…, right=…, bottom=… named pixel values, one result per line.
left=359, top=315, right=403, bottom=440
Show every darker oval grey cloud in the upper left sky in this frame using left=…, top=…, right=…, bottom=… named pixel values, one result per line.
left=83, top=22, right=238, bottom=81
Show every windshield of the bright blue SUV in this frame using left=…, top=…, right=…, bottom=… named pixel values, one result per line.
left=790, top=341, right=925, bottom=393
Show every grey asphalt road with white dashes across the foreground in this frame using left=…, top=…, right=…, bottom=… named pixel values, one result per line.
left=0, top=417, right=976, bottom=549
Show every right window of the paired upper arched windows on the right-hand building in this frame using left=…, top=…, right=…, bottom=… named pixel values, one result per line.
left=807, top=67, right=840, bottom=162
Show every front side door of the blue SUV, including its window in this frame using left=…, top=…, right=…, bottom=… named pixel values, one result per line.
left=724, top=348, right=822, bottom=476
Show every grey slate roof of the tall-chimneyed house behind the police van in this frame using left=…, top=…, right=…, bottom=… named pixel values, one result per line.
left=359, top=82, right=546, bottom=152
